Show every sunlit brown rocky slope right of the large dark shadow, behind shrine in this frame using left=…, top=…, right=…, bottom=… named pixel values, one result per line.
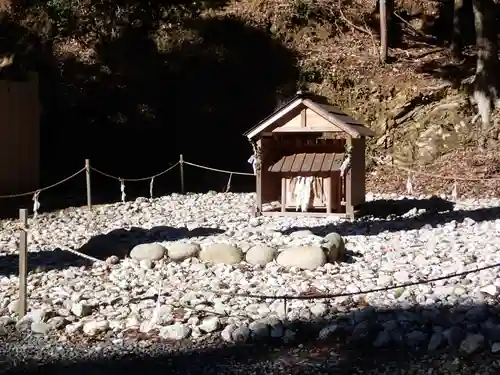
left=225, top=0, right=500, bottom=196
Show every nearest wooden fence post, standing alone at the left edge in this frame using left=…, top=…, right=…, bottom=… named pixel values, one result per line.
left=18, top=208, right=28, bottom=318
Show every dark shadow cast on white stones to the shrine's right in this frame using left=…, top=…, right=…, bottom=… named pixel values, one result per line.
left=283, top=197, right=500, bottom=236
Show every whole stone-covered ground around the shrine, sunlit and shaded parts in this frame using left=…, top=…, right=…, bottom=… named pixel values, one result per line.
left=0, top=193, right=500, bottom=374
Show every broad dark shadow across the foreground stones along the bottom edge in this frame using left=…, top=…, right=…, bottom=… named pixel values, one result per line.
left=0, top=301, right=500, bottom=375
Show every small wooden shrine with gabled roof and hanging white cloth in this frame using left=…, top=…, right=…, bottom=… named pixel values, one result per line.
left=245, top=92, right=375, bottom=218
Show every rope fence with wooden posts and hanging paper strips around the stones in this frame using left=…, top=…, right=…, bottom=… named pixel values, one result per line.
left=5, top=155, right=500, bottom=317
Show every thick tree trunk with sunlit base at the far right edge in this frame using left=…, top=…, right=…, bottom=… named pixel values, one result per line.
left=473, top=0, right=499, bottom=140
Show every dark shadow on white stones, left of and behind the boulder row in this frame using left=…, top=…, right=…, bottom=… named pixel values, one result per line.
left=0, top=226, right=224, bottom=275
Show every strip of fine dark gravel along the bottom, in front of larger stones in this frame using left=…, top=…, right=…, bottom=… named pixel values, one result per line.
left=0, top=326, right=500, bottom=375
